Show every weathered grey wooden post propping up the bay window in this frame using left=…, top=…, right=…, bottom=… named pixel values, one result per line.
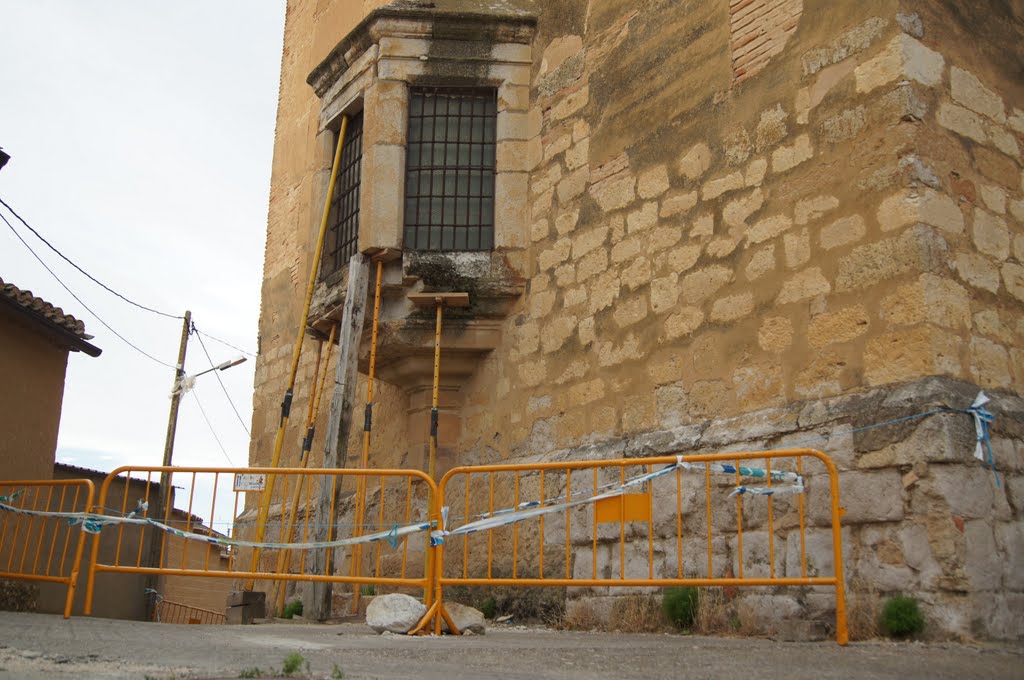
left=310, top=253, right=370, bottom=621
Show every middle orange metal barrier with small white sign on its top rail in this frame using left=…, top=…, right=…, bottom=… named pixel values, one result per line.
left=85, top=466, right=439, bottom=630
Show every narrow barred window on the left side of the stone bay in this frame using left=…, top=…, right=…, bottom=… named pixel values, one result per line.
left=321, top=112, right=362, bottom=278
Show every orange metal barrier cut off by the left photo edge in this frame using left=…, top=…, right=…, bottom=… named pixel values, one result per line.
left=0, top=479, right=94, bottom=619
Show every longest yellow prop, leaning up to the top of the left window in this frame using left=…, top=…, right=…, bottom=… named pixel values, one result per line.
left=245, top=116, right=348, bottom=590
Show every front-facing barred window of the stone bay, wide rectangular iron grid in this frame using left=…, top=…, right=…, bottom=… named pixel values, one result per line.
left=403, top=87, right=498, bottom=251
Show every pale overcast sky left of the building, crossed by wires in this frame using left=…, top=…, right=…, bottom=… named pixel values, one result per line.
left=0, top=0, right=285, bottom=524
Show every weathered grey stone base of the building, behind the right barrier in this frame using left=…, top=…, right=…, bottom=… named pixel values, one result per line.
left=445, top=378, right=1024, bottom=639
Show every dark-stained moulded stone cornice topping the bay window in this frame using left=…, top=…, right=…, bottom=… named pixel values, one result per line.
left=306, top=3, right=537, bottom=97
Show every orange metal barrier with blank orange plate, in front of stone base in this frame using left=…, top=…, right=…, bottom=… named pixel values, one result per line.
left=434, top=449, right=848, bottom=644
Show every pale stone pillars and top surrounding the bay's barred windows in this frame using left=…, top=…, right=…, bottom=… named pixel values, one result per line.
left=308, top=8, right=536, bottom=270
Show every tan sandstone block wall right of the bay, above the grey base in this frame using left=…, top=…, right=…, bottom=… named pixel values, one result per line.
left=464, top=7, right=1024, bottom=462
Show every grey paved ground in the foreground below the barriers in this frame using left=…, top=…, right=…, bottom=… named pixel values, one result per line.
left=0, top=611, right=1024, bottom=680
